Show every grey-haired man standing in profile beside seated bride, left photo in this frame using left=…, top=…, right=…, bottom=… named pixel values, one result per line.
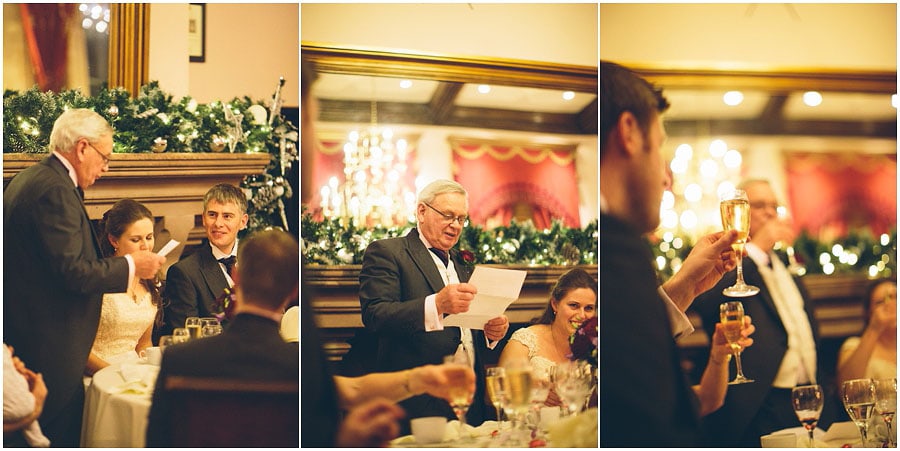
left=3, top=109, right=165, bottom=447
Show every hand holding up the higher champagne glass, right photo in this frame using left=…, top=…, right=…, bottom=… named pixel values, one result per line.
left=662, top=230, right=737, bottom=312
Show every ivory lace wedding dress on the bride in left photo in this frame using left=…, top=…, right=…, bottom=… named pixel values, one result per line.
left=91, top=293, right=156, bottom=363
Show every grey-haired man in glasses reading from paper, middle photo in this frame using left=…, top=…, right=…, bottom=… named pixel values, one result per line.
left=359, top=180, right=509, bottom=434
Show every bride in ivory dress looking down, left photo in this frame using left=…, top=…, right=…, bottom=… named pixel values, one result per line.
left=84, top=199, right=161, bottom=376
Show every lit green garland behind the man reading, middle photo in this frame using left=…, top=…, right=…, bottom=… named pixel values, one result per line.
left=300, top=212, right=597, bottom=265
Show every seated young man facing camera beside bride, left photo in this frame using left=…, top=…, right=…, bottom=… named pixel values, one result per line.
left=157, top=183, right=249, bottom=339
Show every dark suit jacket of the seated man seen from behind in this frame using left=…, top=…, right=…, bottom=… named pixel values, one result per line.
left=146, top=313, right=300, bottom=447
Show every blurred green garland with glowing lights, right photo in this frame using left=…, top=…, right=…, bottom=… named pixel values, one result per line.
left=648, top=228, right=897, bottom=279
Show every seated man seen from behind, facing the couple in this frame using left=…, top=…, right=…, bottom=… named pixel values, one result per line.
left=146, top=230, right=300, bottom=447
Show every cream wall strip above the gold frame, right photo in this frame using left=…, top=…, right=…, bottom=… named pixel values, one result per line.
left=600, top=3, right=897, bottom=71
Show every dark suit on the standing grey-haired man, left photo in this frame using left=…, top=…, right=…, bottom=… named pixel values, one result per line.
left=3, top=155, right=128, bottom=446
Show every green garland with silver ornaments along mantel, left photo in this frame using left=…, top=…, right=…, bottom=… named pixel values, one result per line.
left=3, top=81, right=298, bottom=232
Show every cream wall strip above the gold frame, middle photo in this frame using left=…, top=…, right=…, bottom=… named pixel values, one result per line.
left=300, top=3, right=597, bottom=66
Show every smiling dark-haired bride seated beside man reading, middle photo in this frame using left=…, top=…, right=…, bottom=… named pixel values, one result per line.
left=498, top=268, right=597, bottom=406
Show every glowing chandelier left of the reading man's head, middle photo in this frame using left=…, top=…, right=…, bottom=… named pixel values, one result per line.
left=320, top=101, right=416, bottom=227
